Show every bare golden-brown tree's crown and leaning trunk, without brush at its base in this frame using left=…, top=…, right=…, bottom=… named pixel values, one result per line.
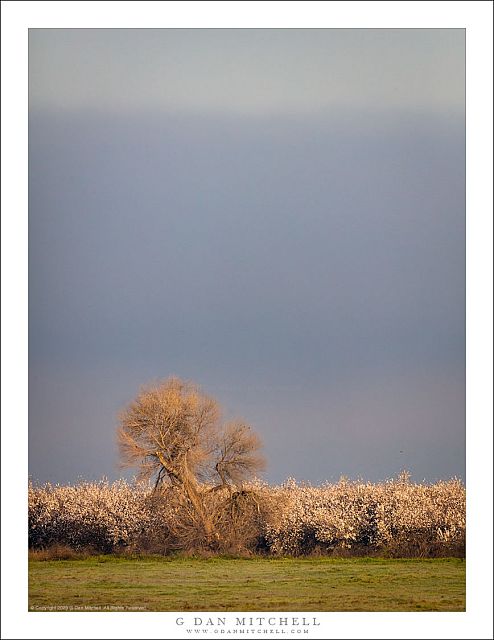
left=117, top=377, right=264, bottom=540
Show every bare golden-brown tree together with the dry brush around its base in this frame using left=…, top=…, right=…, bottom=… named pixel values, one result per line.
left=118, top=377, right=264, bottom=549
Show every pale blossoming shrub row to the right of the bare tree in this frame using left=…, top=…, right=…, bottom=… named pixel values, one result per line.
left=266, top=476, right=465, bottom=555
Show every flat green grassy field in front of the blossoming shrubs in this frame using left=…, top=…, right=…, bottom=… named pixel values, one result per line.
left=29, top=556, right=465, bottom=611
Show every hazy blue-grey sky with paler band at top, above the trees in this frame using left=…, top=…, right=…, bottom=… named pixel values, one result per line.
left=29, top=29, right=465, bottom=482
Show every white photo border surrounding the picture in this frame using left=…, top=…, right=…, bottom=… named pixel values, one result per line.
left=2, top=1, right=493, bottom=638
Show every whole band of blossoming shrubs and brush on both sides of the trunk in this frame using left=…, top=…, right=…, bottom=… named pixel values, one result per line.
left=29, top=475, right=465, bottom=555
